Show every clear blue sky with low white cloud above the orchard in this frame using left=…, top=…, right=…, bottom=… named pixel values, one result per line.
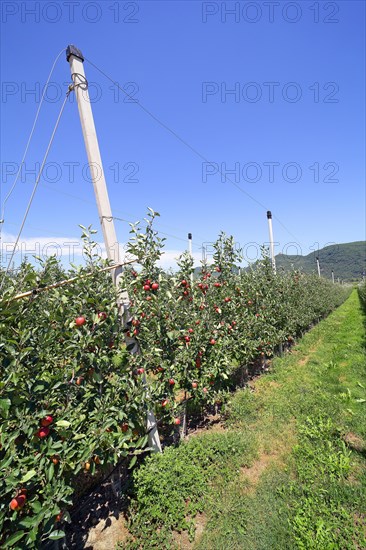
left=1, top=0, right=365, bottom=265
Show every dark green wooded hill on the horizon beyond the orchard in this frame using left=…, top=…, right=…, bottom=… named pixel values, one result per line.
left=276, top=241, right=366, bottom=281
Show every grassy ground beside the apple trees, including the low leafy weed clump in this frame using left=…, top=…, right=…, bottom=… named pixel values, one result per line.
left=123, top=291, right=366, bottom=550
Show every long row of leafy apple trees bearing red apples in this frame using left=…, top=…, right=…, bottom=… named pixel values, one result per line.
left=0, top=216, right=348, bottom=548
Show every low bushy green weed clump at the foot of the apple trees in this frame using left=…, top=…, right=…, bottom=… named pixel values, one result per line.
left=124, top=431, right=255, bottom=549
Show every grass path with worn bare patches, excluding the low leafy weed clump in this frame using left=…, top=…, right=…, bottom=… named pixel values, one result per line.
left=195, top=292, right=366, bottom=550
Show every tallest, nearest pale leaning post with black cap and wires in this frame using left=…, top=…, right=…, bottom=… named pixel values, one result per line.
left=66, top=45, right=161, bottom=452
